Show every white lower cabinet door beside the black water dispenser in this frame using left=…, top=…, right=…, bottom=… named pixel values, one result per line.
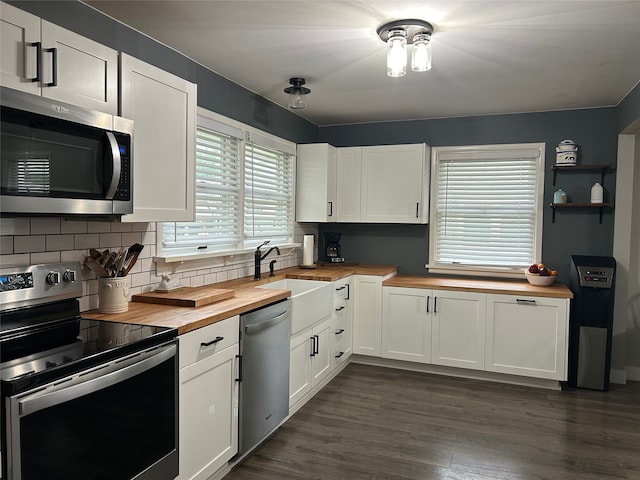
left=486, top=294, right=569, bottom=380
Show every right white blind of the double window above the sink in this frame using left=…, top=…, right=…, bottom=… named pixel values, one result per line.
left=244, top=140, right=294, bottom=243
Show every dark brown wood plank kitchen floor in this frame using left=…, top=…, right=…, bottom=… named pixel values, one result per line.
left=224, top=364, right=640, bottom=480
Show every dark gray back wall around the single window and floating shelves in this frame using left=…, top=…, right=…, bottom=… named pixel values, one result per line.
left=320, top=108, right=618, bottom=282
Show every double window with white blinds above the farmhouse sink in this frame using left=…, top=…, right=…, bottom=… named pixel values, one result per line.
left=160, top=116, right=295, bottom=255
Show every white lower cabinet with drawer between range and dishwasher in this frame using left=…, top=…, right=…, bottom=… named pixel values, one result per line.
left=179, top=316, right=239, bottom=480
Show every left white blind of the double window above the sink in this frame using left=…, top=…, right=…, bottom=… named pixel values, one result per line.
left=162, top=126, right=242, bottom=251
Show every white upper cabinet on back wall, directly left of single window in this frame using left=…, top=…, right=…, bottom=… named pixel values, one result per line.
left=337, top=143, right=429, bottom=223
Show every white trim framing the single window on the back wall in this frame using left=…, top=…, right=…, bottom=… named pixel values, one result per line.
left=425, top=142, right=545, bottom=278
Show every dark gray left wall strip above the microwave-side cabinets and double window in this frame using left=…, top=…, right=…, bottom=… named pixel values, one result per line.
left=7, top=1, right=318, bottom=143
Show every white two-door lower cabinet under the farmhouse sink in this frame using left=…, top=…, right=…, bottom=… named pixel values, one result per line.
left=289, top=316, right=332, bottom=408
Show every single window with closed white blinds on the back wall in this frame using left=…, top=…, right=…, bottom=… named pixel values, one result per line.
left=429, top=143, right=544, bottom=271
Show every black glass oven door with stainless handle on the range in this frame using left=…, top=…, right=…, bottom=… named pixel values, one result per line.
left=7, top=341, right=178, bottom=480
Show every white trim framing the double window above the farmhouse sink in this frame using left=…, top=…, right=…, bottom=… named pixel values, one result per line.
left=160, top=107, right=300, bottom=264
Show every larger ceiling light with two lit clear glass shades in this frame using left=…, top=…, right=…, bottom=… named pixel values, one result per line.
left=377, top=19, right=433, bottom=77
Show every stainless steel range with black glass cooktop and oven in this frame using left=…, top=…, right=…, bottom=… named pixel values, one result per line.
left=0, top=262, right=178, bottom=480
